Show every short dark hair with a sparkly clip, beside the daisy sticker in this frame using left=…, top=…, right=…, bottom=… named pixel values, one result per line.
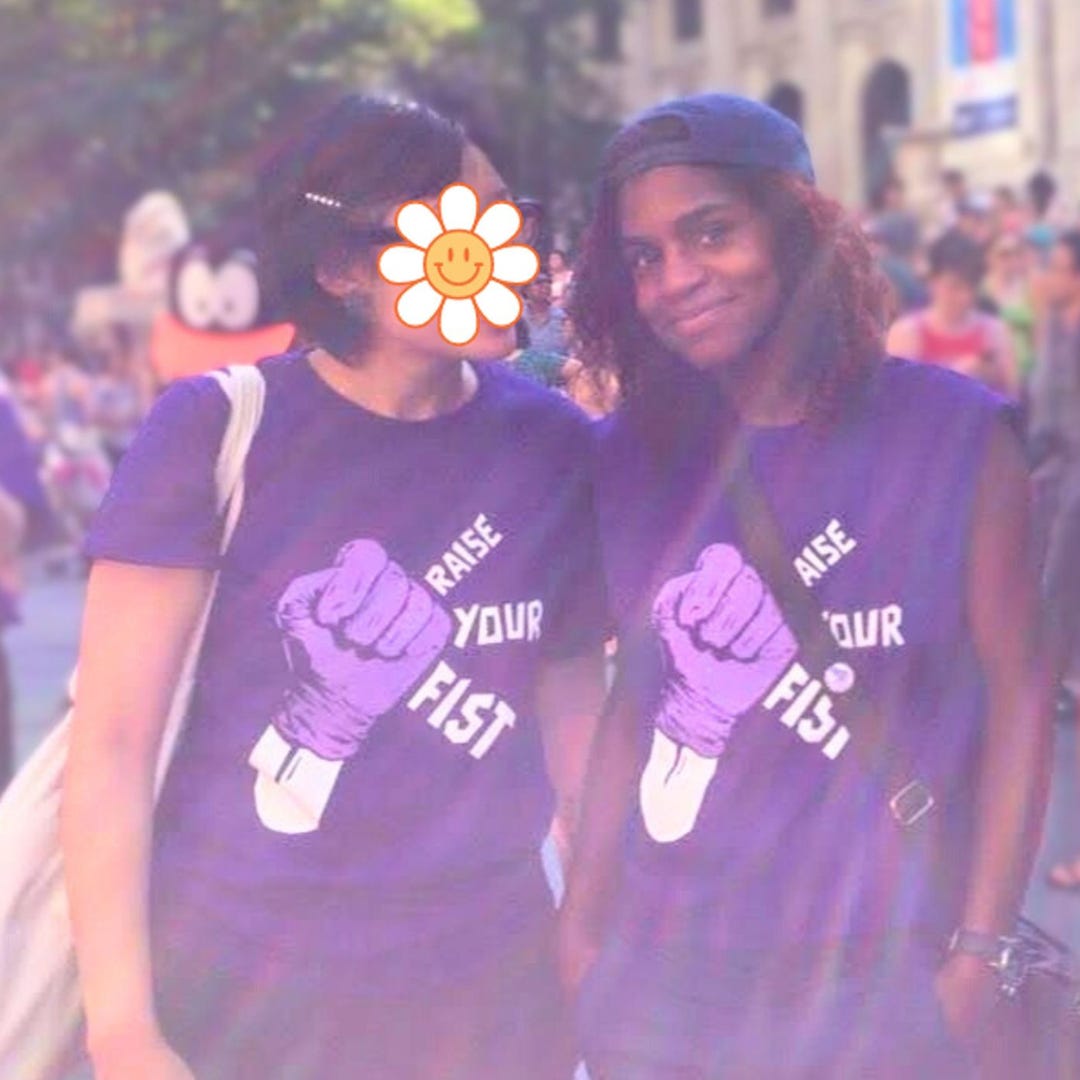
left=259, top=94, right=468, bottom=353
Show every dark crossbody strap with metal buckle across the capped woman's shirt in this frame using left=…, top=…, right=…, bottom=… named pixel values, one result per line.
left=727, top=454, right=934, bottom=828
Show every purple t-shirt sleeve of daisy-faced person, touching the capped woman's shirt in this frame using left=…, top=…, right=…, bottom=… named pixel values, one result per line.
left=543, top=426, right=611, bottom=660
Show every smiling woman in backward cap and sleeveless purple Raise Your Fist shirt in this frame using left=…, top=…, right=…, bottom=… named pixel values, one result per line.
left=561, top=94, right=1050, bottom=1080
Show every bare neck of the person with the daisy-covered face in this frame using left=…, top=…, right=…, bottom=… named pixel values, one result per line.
left=311, top=349, right=477, bottom=420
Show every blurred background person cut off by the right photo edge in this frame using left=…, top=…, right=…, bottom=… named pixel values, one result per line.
left=1028, top=229, right=1080, bottom=892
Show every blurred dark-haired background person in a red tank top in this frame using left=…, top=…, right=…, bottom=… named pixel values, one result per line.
left=886, top=231, right=1020, bottom=397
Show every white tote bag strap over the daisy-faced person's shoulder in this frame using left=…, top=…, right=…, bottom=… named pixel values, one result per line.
left=154, top=365, right=266, bottom=796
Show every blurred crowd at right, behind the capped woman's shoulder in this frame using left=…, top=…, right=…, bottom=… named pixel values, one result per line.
left=863, top=171, right=1080, bottom=704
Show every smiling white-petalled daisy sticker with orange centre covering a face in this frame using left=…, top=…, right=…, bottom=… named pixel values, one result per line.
left=379, top=184, right=540, bottom=345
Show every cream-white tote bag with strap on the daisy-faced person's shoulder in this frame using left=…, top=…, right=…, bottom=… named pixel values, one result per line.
left=0, top=367, right=266, bottom=1080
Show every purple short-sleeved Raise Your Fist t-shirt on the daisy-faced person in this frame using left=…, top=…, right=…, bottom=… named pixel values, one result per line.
left=86, top=354, right=606, bottom=980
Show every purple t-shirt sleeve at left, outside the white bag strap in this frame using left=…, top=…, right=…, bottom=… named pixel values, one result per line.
left=83, top=376, right=229, bottom=570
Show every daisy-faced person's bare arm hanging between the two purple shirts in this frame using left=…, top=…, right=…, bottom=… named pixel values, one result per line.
left=537, top=648, right=606, bottom=870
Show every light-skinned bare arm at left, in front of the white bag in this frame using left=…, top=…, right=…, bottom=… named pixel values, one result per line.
left=60, top=562, right=212, bottom=1080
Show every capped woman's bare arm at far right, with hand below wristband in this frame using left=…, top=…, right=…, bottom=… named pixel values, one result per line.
left=937, top=414, right=1054, bottom=1037
